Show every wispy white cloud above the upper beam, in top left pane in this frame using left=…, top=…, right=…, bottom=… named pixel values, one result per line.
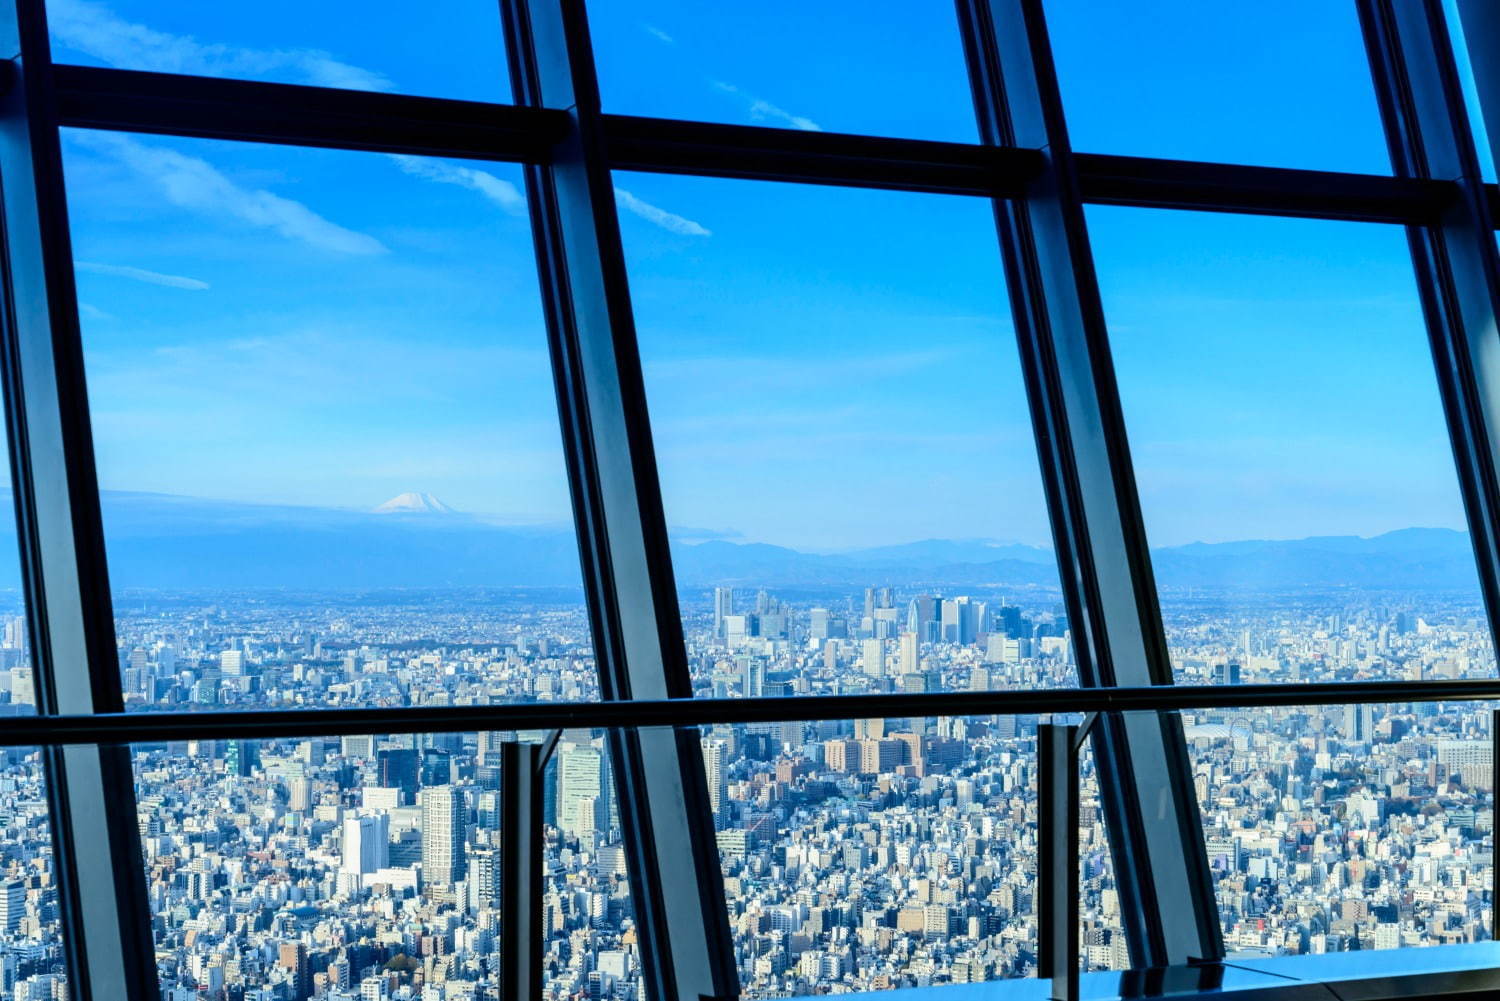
left=47, top=0, right=393, bottom=90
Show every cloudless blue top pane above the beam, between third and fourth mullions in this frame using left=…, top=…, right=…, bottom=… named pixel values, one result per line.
left=1046, top=0, right=1391, bottom=174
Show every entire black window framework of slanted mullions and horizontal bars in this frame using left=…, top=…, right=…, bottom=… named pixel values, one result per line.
left=0, top=0, right=1500, bottom=1001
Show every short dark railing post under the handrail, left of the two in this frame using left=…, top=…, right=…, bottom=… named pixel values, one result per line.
left=500, top=741, right=543, bottom=1001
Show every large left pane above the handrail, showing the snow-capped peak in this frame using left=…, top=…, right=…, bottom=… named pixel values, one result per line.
left=66, top=132, right=597, bottom=707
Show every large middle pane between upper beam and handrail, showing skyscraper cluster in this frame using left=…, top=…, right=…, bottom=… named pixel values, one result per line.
left=617, top=176, right=1074, bottom=695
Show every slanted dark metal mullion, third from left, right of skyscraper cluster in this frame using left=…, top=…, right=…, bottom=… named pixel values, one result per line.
left=959, top=0, right=1224, bottom=966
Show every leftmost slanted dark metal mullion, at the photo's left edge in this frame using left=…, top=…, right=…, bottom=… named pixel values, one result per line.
left=0, top=0, right=159, bottom=1001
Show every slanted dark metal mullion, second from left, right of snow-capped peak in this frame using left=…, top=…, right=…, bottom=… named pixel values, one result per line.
left=501, top=0, right=740, bottom=1001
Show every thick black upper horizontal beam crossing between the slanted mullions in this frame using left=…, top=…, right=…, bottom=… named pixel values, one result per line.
left=54, top=65, right=1500, bottom=225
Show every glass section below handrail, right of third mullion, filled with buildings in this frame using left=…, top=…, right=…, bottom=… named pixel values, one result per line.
left=1184, top=702, right=1494, bottom=956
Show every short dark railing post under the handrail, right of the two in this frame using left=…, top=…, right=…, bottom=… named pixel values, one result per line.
left=1037, top=723, right=1079, bottom=1001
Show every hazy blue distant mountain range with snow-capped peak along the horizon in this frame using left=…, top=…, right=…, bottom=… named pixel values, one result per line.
left=0, top=491, right=1478, bottom=593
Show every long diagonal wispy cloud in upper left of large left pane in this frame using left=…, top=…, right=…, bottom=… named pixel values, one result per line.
left=74, top=132, right=386, bottom=255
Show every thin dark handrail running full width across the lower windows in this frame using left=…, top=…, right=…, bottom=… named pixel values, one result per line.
left=17, top=678, right=1500, bottom=747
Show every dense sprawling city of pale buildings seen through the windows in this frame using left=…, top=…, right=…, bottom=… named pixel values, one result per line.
left=0, top=587, right=1496, bottom=1001
